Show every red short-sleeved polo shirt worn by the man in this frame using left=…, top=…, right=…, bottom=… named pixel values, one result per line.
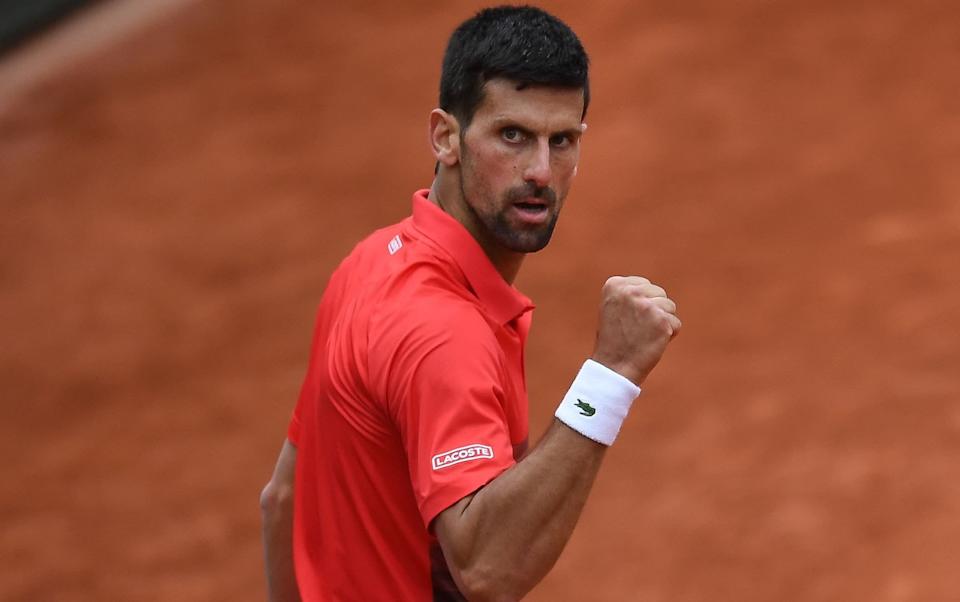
left=288, top=190, right=533, bottom=602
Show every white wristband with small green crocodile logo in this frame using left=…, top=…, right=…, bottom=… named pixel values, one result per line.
left=554, top=360, right=640, bottom=445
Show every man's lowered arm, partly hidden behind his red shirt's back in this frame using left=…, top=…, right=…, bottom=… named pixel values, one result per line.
left=260, top=439, right=300, bottom=602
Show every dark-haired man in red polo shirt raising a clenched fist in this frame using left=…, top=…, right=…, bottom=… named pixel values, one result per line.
left=261, top=7, right=680, bottom=602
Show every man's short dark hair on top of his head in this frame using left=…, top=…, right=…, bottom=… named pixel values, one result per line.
left=440, top=6, right=590, bottom=129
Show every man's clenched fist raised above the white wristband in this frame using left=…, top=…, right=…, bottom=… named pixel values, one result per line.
left=591, top=276, right=680, bottom=386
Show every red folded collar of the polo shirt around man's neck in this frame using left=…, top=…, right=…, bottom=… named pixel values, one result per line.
left=413, top=189, right=533, bottom=326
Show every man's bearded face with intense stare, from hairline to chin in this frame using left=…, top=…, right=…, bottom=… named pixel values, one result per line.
left=460, top=79, right=583, bottom=253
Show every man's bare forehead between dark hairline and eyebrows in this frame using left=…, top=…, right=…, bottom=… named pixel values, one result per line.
left=473, top=78, right=583, bottom=131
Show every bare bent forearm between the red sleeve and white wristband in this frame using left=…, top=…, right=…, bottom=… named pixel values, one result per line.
left=437, top=421, right=607, bottom=600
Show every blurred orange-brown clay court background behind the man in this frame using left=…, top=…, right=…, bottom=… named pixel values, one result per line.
left=0, top=0, right=960, bottom=602
